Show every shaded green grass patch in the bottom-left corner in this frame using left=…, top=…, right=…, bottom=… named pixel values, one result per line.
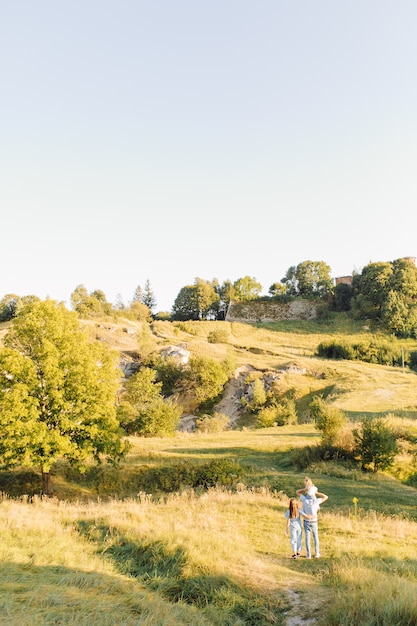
left=0, top=562, right=161, bottom=626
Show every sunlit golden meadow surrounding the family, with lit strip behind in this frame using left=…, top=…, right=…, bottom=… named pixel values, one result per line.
left=0, top=425, right=417, bottom=626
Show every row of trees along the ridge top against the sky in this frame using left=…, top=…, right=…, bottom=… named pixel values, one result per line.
left=0, top=258, right=417, bottom=337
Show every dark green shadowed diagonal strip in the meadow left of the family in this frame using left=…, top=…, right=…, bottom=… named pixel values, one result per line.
left=78, top=521, right=287, bottom=626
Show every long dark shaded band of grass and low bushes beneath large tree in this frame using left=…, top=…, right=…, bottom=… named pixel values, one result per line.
left=0, top=447, right=310, bottom=500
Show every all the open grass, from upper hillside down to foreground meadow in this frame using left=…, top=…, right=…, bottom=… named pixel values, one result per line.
left=0, top=316, right=417, bottom=626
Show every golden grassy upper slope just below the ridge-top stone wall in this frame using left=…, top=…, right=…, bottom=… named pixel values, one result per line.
left=146, top=314, right=417, bottom=419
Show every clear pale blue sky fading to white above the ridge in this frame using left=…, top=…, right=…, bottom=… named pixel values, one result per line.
left=0, top=0, right=417, bottom=310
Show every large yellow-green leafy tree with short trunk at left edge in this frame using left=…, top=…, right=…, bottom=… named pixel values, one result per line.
left=0, top=300, right=126, bottom=495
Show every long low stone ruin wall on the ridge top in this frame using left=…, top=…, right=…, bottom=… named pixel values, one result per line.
left=226, top=300, right=317, bottom=322
